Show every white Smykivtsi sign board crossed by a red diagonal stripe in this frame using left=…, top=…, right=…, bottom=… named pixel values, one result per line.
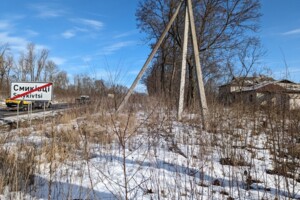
left=10, top=82, right=53, bottom=101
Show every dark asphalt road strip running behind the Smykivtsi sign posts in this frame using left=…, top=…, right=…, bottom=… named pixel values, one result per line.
left=0, top=103, right=71, bottom=119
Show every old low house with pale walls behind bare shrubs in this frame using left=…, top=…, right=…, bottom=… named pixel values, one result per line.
left=219, top=76, right=300, bottom=110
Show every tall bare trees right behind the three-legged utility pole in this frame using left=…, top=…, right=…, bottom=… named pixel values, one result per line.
left=136, top=0, right=260, bottom=105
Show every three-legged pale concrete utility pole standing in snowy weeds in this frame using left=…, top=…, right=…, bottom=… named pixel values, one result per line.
left=117, top=0, right=208, bottom=129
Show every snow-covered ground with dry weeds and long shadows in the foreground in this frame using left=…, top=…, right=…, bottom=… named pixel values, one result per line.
left=1, top=108, right=300, bottom=199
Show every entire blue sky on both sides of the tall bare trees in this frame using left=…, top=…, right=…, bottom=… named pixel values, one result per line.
left=0, top=0, right=300, bottom=90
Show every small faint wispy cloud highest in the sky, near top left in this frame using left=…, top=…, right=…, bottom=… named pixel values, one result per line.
left=30, top=3, right=66, bottom=18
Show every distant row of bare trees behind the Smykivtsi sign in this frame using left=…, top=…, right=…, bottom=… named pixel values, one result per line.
left=0, top=43, right=122, bottom=98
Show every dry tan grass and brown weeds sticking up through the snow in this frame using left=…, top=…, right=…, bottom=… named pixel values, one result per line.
left=0, top=95, right=300, bottom=196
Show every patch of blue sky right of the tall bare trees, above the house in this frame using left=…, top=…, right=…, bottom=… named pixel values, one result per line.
left=259, top=0, right=300, bottom=83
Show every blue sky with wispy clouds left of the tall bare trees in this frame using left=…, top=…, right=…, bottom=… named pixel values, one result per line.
left=0, top=0, right=150, bottom=90
